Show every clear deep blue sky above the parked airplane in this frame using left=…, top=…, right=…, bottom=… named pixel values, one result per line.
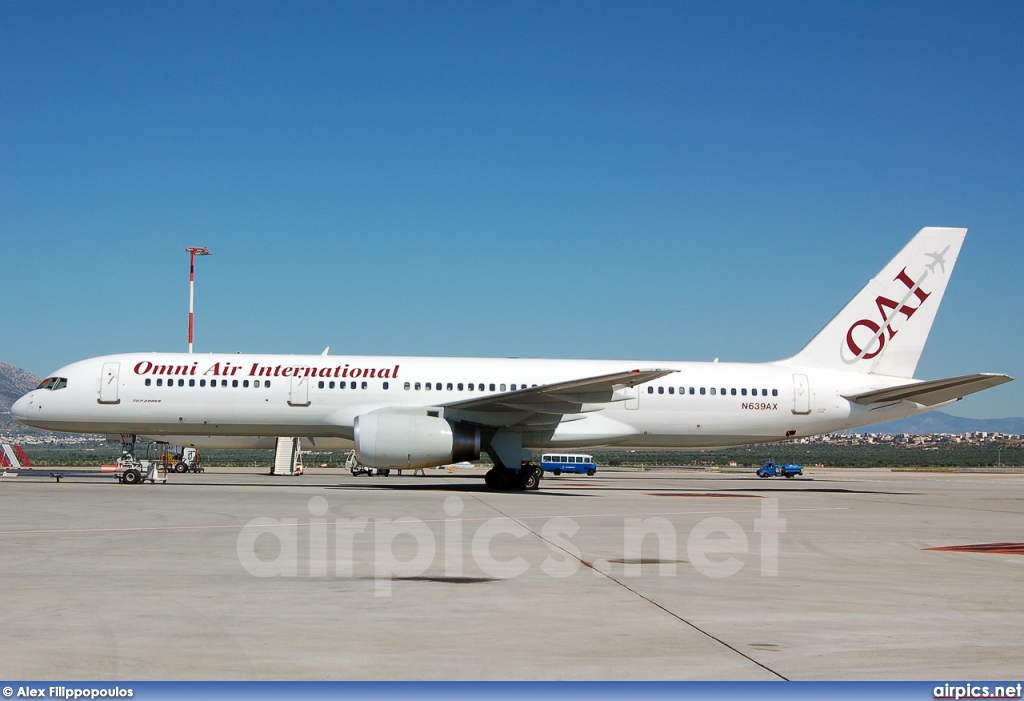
left=0, top=0, right=1024, bottom=418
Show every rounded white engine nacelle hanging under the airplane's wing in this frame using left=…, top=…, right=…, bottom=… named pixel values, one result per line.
left=353, top=412, right=480, bottom=470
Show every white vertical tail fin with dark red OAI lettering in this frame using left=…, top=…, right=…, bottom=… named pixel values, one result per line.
left=784, top=226, right=967, bottom=378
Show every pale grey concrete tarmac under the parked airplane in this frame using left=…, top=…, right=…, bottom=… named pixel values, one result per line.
left=0, top=468, right=1024, bottom=681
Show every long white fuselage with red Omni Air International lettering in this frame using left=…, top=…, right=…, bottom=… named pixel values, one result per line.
left=11, top=353, right=935, bottom=449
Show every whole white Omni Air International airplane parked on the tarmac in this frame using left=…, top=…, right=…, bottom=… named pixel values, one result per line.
left=10, top=227, right=1013, bottom=489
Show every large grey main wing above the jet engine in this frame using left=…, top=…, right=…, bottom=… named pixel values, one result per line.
left=442, top=368, right=678, bottom=428
